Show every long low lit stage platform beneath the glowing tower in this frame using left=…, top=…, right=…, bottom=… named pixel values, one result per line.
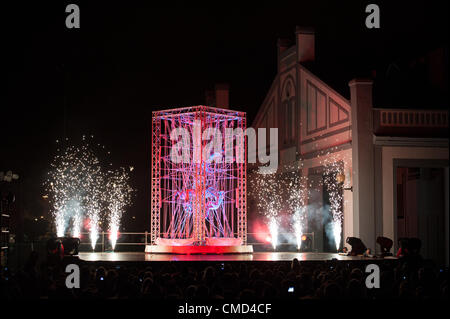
left=78, top=252, right=396, bottom=262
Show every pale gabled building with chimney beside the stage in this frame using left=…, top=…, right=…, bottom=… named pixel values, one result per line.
left=251, top=28, right=448, bottom=264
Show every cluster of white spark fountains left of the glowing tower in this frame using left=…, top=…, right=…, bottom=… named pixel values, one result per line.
left=44, top=137, right=133, bottom=249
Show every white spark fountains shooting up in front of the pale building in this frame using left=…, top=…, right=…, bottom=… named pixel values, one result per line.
left=250, top=154, right=345, bottom=250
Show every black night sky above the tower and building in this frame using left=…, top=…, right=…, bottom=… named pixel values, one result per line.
left=0, top=1, right=448, bottom=231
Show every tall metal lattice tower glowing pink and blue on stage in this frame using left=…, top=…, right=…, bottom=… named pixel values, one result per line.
left=146, top=106, right=253, bottom=253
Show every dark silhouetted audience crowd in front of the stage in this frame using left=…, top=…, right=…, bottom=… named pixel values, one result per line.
left=1, top=252, right=448, bottom=300
